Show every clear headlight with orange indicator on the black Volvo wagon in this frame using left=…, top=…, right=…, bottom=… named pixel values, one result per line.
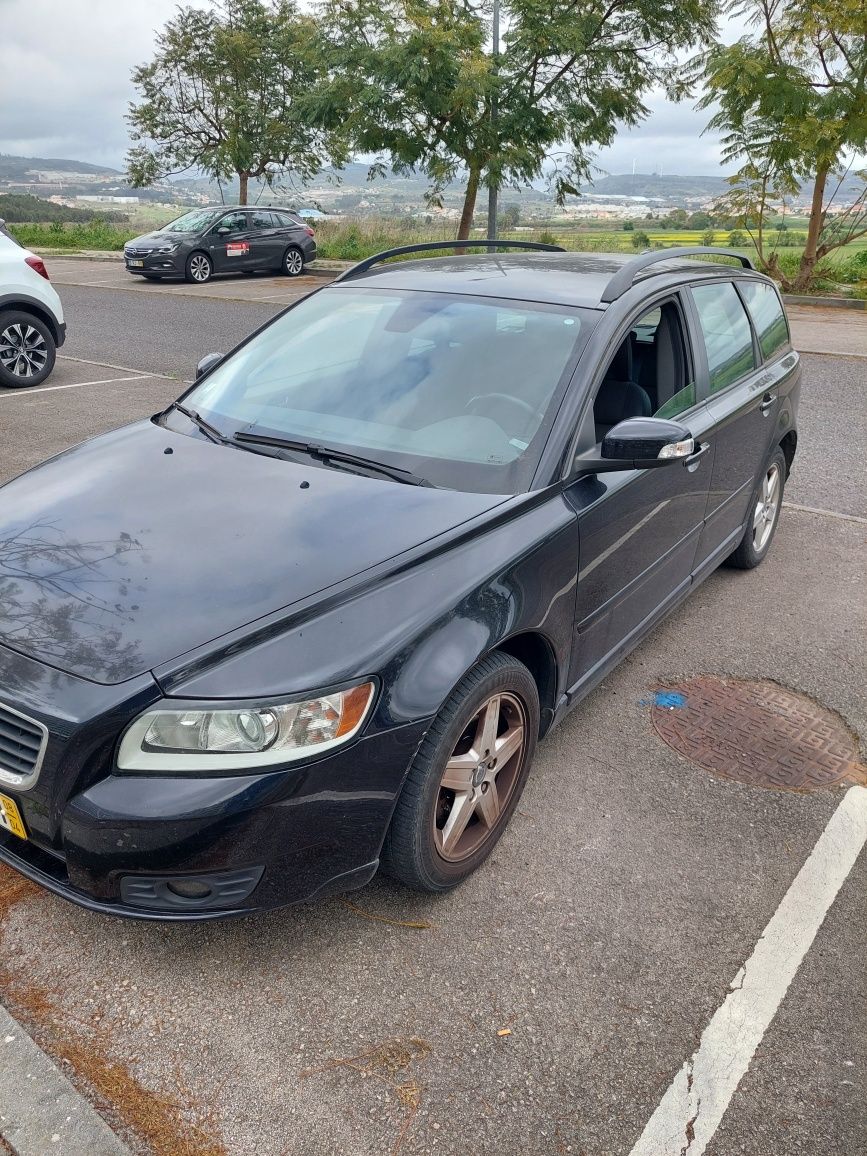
left=118, top=682, right=373, bottom=773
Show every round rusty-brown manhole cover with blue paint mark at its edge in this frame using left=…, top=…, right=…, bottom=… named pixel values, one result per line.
left=651, top=675, right=867, bottom=791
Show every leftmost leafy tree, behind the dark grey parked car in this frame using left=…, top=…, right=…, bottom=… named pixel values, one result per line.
left=127, top=0, right=346, bottom=205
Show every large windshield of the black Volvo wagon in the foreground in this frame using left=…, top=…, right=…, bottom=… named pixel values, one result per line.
left=184, top=287, right=594, bottom=494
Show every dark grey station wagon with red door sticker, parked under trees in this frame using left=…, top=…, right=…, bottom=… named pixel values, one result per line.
left=124, top=206, right=316, bottom=284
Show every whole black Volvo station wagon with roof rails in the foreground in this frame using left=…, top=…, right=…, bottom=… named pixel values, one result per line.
left=0, top=243, right=800, bottom=919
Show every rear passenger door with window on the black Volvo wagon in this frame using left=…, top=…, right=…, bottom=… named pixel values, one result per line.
left=690, top=280, right=787, bottom=570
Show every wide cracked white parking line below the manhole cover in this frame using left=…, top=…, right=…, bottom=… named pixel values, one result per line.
left=630, top=787, right=867, bottom=1156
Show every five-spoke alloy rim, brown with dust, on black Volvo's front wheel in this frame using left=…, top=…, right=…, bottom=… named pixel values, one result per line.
left=434, top=694, right=527, bottom=862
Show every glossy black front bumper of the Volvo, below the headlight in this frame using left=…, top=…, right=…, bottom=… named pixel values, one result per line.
left=0, top=724, right=425, bottom=920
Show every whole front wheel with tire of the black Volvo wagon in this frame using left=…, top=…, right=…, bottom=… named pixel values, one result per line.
left=381, top=652, right=539, bottom=892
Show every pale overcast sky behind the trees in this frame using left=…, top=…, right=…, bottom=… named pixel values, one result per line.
left=0, top=0, right=735, bottom=173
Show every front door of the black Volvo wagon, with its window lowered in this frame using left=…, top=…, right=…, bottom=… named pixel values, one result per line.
left=565, top=297, right=714, bottom=695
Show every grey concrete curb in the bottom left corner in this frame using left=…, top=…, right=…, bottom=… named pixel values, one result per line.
left=0, top=1006, right=132, bottom=1156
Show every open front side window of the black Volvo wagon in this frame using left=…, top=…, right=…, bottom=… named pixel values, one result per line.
left=593, top=301, right=696, bottom=442
